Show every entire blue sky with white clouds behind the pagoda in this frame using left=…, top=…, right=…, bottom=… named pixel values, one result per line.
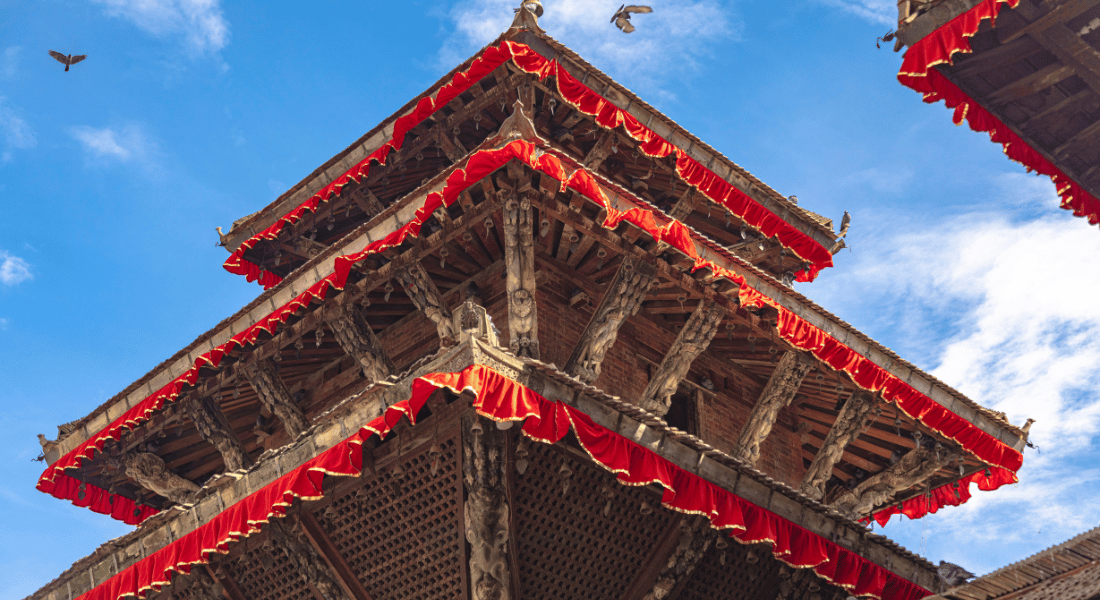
left=0, top=0, right=1100, bottom=598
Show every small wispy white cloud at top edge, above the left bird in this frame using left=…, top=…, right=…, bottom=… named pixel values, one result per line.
left=94, top=0, right=229, bottom=54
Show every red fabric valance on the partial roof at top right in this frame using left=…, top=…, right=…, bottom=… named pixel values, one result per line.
left=898, top=0, right=1100, bottom=225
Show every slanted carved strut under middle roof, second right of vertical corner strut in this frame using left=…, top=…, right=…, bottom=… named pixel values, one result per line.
left=641, top=298, right=726, bottom=416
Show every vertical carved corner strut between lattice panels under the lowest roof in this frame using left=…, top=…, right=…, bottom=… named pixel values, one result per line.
left=462, top=414, right=512, bottom=600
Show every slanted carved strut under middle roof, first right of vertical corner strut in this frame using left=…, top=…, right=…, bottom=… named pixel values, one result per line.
left=565, top=257, right=657, bottom=383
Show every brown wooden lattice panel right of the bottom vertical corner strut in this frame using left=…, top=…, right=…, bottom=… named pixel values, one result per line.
left=515, top=444, right=680, bottom=600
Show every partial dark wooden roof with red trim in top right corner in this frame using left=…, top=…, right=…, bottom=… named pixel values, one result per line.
left=894, top=0, right=1100, bottom=225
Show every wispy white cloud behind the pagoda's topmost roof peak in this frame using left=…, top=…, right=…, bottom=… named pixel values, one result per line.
left=440, top=0, right=741, bottom=97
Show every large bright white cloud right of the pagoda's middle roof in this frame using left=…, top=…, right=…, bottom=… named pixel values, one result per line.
left=815, top=174, right=1100, bottom=571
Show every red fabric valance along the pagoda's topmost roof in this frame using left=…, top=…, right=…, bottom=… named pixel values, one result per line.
left=223, top=41, right=833, bottom=288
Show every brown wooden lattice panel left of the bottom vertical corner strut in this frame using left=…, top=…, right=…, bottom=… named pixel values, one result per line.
left=317, top=437, right=466, bottom=600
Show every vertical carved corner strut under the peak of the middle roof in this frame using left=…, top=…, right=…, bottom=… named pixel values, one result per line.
left=504, top=190, right=539, bottom=359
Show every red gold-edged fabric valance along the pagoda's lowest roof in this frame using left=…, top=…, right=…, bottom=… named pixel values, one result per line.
left=78, top=366, right=931, bottom=600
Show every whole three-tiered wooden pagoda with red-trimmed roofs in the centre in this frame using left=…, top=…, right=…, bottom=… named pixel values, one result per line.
left=31, top=0, right=1027, bottom=600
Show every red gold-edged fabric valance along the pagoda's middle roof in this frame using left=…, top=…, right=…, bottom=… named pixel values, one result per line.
left=39, top=141, right=1023, bottom=524
